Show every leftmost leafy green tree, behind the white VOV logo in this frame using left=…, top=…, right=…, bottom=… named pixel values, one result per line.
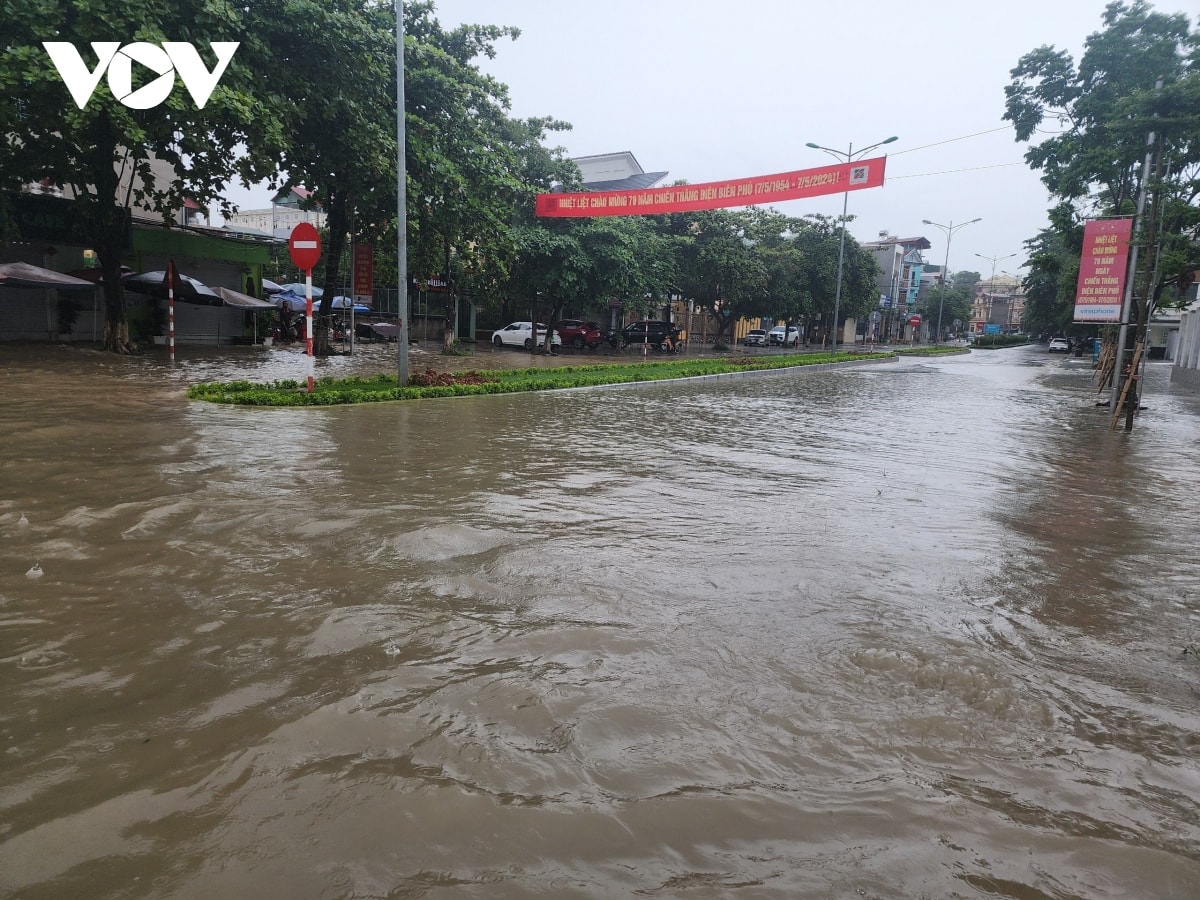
left=0, top=0, right=278, bottom=353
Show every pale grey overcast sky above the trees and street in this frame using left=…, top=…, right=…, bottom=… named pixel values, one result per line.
left=229, top=0, right=1166, bottom=278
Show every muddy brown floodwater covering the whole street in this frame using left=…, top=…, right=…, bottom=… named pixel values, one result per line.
left=0, top=346, right=1200, bottom=900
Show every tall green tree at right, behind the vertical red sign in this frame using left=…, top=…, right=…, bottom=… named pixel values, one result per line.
left=1004, top=0, right=1200, bottom=348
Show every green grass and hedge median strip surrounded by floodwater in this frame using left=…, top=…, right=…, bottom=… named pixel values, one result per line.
left=187, top=353, right=894, bottom=407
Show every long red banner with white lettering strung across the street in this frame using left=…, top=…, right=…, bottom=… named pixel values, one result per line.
left=538, top=156, right=887, bottom=218
